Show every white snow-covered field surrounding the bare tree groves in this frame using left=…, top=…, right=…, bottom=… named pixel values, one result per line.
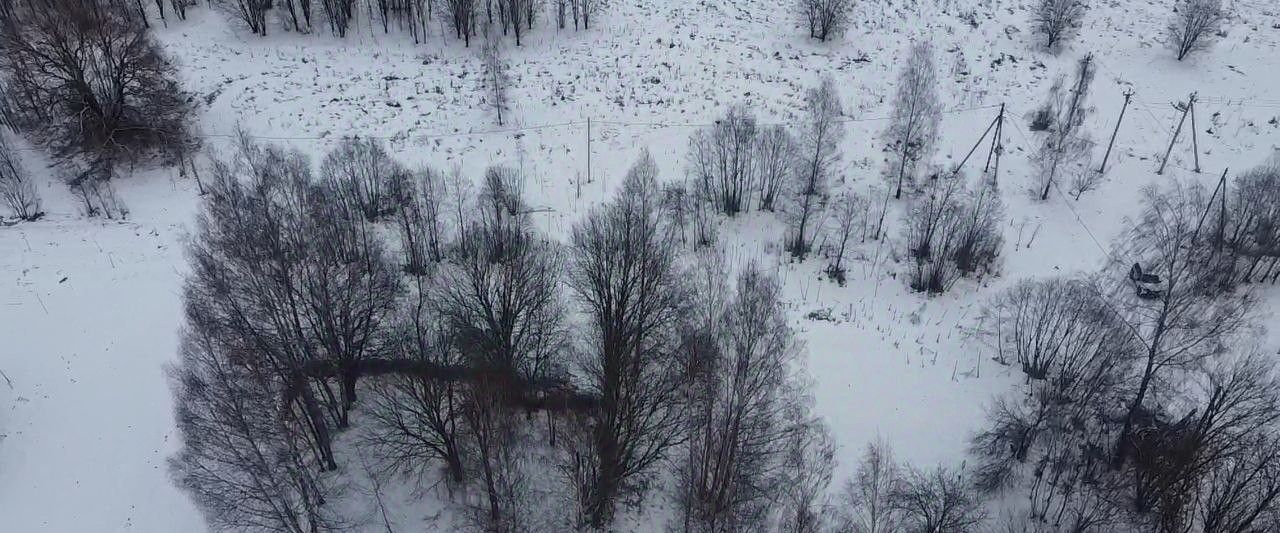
left=0, top=0, right=1280, bottom=533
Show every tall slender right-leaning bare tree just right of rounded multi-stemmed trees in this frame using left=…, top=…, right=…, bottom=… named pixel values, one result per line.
left=787, top=77, right=845, bottom=260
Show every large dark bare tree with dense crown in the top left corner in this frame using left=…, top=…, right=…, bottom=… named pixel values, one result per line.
left=0, top=0, right=192, bottom=161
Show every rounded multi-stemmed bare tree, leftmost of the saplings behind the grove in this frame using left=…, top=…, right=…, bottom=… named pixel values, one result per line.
left=689, top=104, right=759, bottom=215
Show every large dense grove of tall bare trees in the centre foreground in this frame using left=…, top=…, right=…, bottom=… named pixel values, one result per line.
left=172, top=131, right=832, bottom=532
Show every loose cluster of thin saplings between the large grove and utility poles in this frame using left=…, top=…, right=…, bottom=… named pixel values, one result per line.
left=691, top=58, right=1004, bottom=293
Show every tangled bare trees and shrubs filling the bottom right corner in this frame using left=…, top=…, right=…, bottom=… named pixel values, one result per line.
left=973, top=165, right=1280, bottom=533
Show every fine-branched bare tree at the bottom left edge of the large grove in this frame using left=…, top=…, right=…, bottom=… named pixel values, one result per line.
left=169, top=325, right=340, bottom=533
